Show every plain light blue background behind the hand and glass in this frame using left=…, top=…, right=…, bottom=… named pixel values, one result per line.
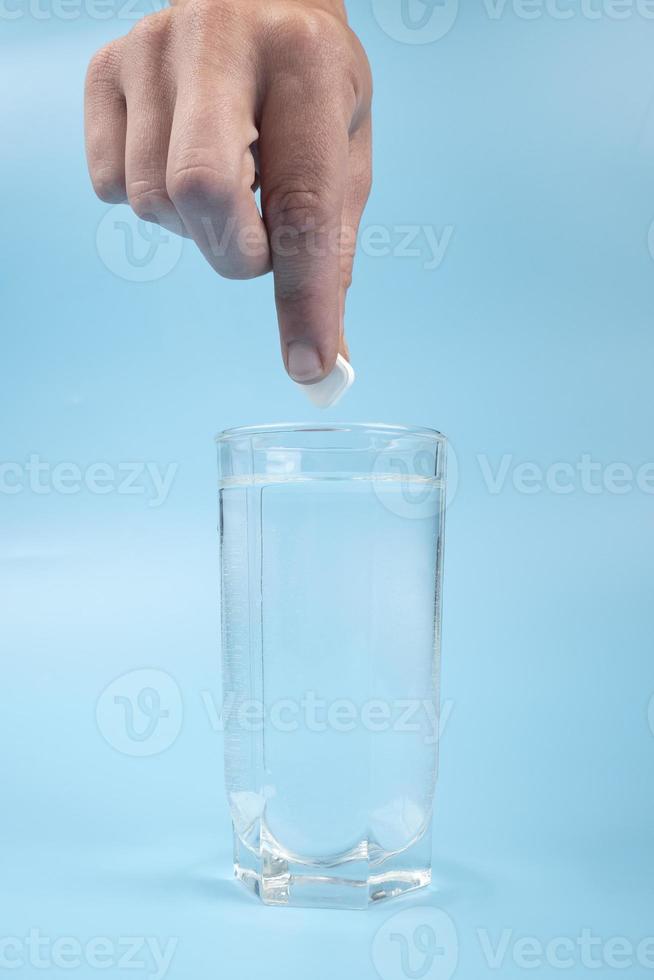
left=0, top=0, right=654, bottom=980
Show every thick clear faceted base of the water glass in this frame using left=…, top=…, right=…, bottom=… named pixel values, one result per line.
left=234, top=831, right=431, bottom=909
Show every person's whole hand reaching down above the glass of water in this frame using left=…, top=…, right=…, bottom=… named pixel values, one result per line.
left=86, top=0, right=372, bottom=383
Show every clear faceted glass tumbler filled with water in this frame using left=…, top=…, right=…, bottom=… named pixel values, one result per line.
left=218, top=424, right=446, bottom=908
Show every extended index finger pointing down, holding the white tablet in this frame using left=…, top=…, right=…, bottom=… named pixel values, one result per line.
left=259, top=76, right=351, bottom=384
